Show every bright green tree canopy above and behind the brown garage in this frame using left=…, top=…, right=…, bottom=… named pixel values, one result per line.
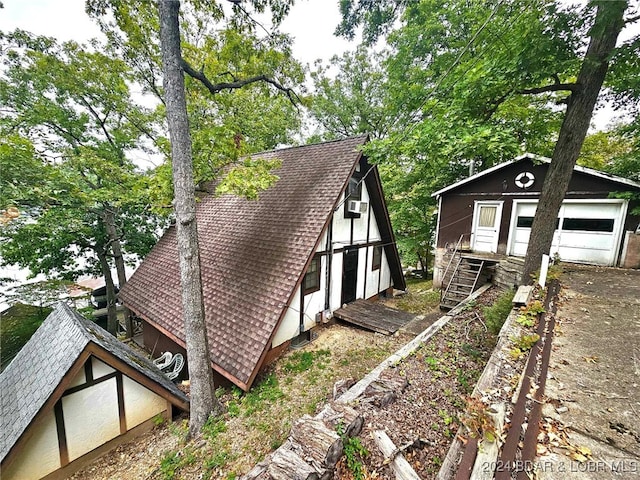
left=312, top=0, right=640, bottom=276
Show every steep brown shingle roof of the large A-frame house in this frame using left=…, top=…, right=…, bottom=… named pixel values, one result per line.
left=120, top=136, right=367, bottom=388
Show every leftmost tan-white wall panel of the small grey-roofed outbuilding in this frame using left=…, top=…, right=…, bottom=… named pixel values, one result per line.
left=0, top=411, right=60, bottom=480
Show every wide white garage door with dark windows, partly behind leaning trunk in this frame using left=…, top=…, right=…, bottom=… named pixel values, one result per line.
left=509, top=200, right=626, bottom=265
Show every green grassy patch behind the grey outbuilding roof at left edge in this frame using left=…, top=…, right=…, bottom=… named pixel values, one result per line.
left=0, top=303, right=52, bottom=370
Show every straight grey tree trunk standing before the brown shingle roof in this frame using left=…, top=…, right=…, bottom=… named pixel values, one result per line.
left=158, top=0, right=222, bottom=435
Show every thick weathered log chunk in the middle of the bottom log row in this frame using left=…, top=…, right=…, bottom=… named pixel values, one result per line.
left=290, top=415, right=343, bottom=471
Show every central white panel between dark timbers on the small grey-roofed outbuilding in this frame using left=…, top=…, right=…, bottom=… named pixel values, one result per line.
left=62, top=378, right=120, bottom=461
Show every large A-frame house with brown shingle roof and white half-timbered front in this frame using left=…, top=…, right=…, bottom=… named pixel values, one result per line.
left=119, top=136, right=405, bottom=390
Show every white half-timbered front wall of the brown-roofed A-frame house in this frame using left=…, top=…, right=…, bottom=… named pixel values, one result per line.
left=272, top=178, right=392, bottom=347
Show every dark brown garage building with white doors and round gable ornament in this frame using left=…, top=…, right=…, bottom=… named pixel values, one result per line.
left=433, top=153, right=640, bottom=284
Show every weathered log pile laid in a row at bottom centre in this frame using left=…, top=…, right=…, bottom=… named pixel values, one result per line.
left=242, top=402, right=364, bottom=480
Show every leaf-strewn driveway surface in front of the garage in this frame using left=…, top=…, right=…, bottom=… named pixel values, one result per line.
left=538, top=265, right=640, bottom=479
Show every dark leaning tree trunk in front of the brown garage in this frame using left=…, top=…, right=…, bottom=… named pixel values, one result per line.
left=522, top=0, right=628, bottom=283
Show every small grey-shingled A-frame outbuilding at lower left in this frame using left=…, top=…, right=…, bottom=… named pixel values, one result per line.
left=0, top=303, right=189, bottom=480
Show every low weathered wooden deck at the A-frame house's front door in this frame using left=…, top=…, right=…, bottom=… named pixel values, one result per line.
left=333, top=300, right=416, bottom=335
